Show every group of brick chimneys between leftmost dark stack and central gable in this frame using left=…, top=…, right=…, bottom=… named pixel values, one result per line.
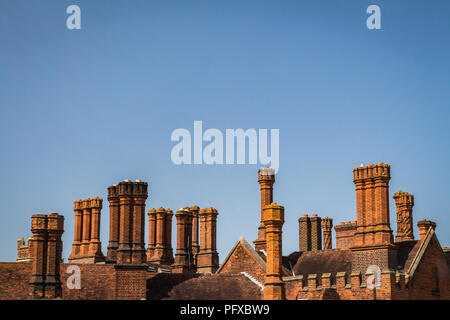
left=69, top=180, right=219, bottom=273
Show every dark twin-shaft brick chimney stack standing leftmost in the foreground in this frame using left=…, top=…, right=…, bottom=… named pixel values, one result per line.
left=30, top=212, right=64, bottom=299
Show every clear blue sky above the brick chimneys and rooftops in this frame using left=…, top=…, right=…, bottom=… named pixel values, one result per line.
left=0, top=0, right=450, bottom=261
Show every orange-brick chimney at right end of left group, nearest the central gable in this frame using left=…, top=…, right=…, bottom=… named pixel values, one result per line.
left=197, top=208, right=219, bottom=273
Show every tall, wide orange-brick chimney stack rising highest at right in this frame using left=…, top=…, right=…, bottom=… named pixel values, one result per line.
left=353, top=163, right=394, bottom=247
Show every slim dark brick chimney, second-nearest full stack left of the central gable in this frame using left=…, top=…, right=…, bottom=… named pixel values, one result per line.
left=172, top=208, right=193, bottom=273
